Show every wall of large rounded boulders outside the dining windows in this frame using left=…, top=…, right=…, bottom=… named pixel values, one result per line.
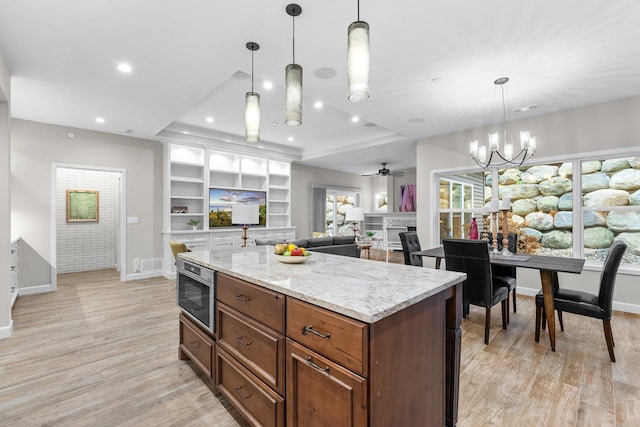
left=485, top=157, right=640, bottom=255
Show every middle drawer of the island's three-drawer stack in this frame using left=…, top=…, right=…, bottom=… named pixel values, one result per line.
left=216, top=304, right=285, bottom=396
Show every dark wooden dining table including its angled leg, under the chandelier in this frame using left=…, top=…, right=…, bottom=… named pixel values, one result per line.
left=413, top=246, right=584, bottom=351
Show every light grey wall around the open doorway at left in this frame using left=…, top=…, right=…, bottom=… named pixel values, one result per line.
left=10, top=120, right=162, bottom=280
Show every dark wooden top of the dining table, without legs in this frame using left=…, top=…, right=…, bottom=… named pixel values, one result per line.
left=413, top=246, right=584, bottom=274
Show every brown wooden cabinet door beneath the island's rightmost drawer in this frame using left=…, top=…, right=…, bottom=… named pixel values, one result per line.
left=287, top=339, right=368, bottom=427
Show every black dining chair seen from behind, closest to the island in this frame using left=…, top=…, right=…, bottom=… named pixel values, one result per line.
left=442, top=239, right=509, bottom=344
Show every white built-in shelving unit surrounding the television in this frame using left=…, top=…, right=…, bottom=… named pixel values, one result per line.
left=164, top=142, right=295, bottom=278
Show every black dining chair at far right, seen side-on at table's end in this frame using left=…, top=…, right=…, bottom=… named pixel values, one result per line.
left=535, top=240, right=627, bottom=362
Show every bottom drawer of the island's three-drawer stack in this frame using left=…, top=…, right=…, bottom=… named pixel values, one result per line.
left=215, top=346, right=284, bottom=427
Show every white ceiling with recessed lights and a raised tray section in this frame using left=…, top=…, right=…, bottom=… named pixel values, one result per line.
left=0, top=0, right=640, bottom=173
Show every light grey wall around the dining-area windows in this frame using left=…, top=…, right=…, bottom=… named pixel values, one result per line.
left=416, top=97, right=640, bottom=309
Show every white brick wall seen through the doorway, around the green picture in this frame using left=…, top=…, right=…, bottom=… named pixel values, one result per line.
left=56, top=167, right=120, bottom=273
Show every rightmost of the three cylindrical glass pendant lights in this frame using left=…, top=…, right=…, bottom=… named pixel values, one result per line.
left=347, top=0, right=370, bottom=102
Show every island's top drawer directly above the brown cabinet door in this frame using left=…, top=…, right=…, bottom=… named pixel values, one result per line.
left=286, top=298, right=369, bottom=376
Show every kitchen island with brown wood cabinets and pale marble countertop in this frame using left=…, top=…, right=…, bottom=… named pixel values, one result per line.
left=179, top=246, right=465, bottom=427
